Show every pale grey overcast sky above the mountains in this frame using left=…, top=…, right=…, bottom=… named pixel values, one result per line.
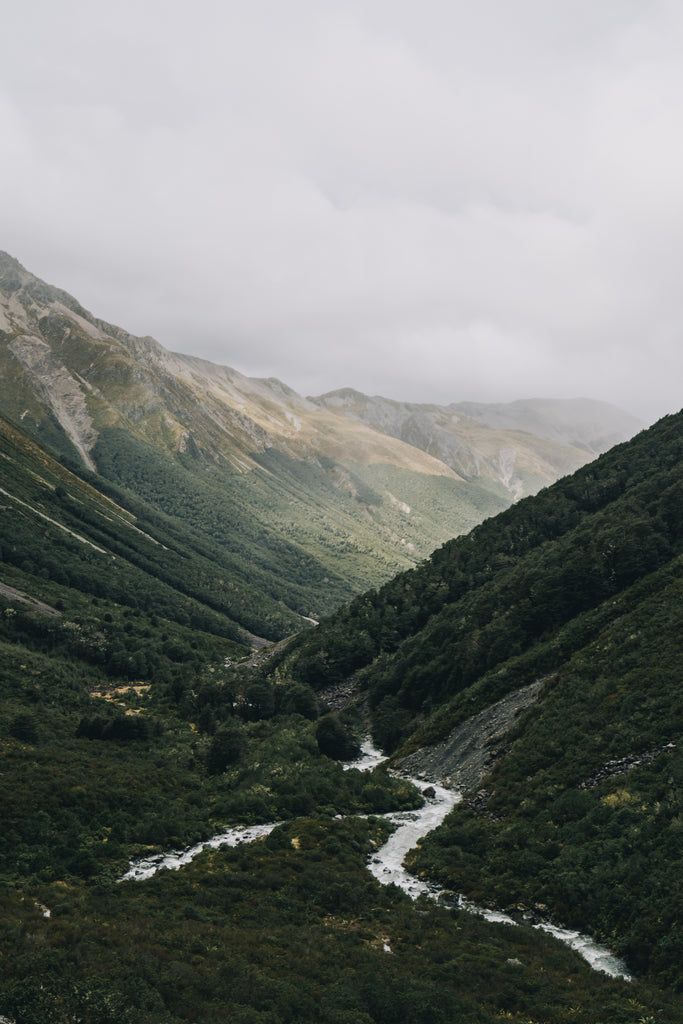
left=0, top=0, right=683, bottom=422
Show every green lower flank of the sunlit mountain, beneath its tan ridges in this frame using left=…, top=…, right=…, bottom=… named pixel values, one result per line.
left=88, top=428, right=504, bottom=622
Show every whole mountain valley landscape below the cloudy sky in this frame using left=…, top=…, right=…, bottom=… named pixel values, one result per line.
left=0, top=249, right=683, bottom=1024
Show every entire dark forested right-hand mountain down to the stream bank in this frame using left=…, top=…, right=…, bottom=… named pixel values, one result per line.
left=272, top=413, right=683, bottom=992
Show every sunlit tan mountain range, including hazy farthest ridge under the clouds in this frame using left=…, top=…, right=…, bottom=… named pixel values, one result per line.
left=0, top=254, right=640, bottom=613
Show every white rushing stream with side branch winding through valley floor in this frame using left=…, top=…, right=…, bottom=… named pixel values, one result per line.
left=119, top=740, right=631, bottom=981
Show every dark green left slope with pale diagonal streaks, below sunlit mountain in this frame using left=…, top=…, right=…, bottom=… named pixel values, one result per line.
left=0, top=409, right=323, bottom=645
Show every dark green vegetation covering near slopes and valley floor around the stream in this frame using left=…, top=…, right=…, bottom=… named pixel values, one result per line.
left=0, top=403, right=683, bottom=1024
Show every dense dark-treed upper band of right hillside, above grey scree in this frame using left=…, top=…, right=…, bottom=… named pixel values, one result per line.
left=276, top=414, right=683, bottom=748
